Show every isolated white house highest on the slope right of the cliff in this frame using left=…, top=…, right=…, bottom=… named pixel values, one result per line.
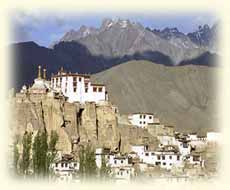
left=128, top=113, right=159, bottom=128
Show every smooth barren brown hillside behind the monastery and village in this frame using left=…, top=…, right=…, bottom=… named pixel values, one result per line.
left=93, top=61, right=218, bottom=132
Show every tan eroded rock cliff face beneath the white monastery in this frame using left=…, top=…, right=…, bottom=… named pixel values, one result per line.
left=10, top=94, right=156, bottom=153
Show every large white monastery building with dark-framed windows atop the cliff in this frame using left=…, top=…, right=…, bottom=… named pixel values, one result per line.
left=51, top=69, right=108, bottom=103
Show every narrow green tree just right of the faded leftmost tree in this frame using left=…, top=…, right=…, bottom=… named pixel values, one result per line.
left=20, top=131, right=32, bottom=176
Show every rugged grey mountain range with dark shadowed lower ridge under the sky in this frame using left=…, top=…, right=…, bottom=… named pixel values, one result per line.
left=10, top=19, right=218, bottom=89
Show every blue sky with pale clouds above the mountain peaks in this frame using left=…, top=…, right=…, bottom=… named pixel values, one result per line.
left=10, top=10, right=218, bottom=47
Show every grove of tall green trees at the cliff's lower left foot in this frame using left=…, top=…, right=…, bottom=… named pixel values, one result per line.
left=13, top=129, right=58, bottom=178
